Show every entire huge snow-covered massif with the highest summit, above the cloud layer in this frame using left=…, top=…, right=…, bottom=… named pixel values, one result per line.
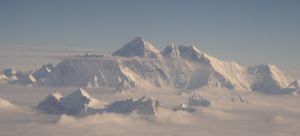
left=14, top=37, right=291, bottom=92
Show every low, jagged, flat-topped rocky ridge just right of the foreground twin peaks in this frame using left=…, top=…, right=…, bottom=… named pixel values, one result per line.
left=105, top=96, right=159, bottom=115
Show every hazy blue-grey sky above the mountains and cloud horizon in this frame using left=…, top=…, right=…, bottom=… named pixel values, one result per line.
left=0, top=0, right=300, bottom=71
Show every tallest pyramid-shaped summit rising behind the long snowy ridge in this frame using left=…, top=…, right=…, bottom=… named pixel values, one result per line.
left=113, top=37, right=160, bottom=58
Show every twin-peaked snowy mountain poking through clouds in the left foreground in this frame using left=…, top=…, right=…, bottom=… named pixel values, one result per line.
left=37, top=88, right=97, bottom=115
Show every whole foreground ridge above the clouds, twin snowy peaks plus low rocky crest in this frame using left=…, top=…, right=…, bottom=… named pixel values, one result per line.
left=37, top=88, right=159, bottom=116
